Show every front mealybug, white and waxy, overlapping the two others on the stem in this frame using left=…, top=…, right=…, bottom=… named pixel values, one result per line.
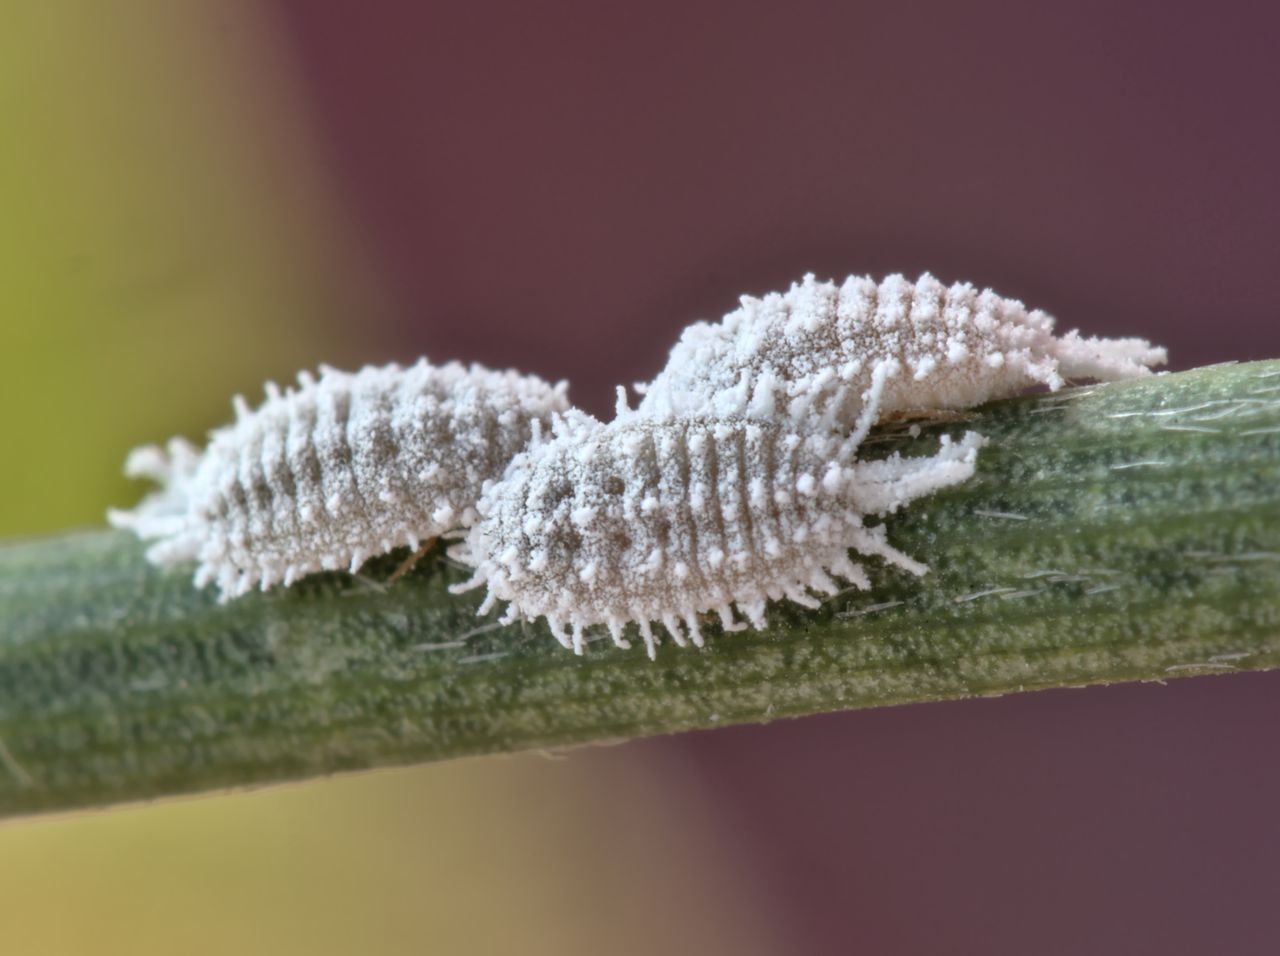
left=454, top=413, right=980, bottom=657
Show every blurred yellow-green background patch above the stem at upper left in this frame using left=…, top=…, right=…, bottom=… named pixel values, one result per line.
left=0, top=0, right=394, bottom=534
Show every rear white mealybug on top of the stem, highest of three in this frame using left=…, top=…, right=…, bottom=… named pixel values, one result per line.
left=634, top=273, right=1165, bottom=427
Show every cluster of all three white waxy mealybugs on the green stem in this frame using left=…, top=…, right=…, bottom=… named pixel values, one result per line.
left=110, top=275, right=1165, bottom=657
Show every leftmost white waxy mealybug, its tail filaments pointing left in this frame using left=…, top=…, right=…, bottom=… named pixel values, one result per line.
left=109, top=360, right=568, bottom=600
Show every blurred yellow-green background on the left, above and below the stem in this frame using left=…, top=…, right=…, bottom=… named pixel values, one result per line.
left=0, top=7, right=763, bottom=956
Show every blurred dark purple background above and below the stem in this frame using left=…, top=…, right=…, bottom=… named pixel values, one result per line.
left=272, top=3, right=1280, bottom=953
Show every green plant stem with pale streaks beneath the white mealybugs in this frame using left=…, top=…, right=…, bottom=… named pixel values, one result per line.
left=0, top=362, right=1280, bottom=814
